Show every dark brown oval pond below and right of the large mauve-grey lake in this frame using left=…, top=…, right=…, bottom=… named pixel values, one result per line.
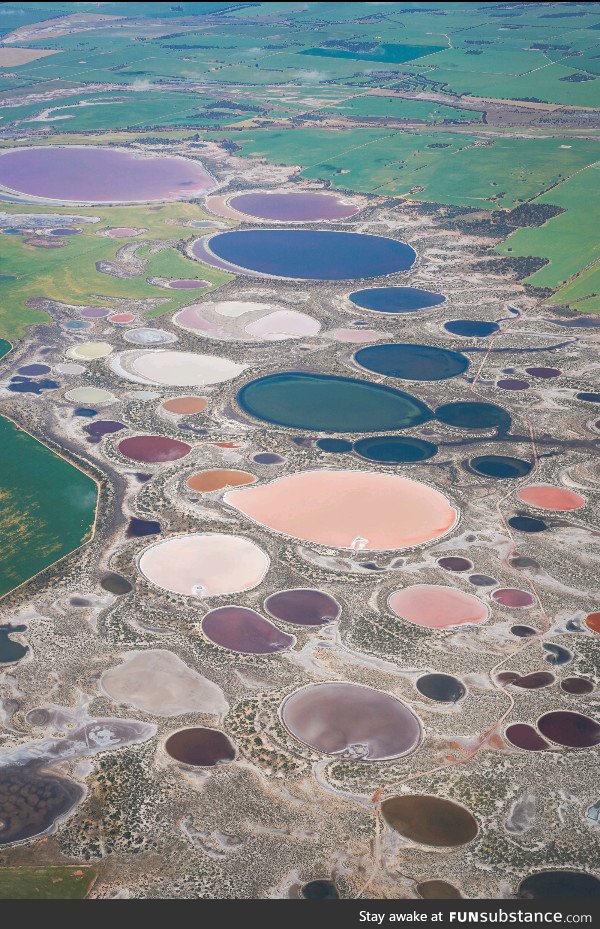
left=381, top=794, right=478, bottom=848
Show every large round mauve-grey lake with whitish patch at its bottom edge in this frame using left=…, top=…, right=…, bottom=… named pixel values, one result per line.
left=281, top=682, right=421, bottom=761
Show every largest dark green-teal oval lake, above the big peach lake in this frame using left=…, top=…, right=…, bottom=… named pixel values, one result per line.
left=237, top=371, right=432, bottom=434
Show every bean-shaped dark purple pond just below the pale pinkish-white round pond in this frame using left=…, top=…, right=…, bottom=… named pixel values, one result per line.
left=202, top=606, right=295, bottom=655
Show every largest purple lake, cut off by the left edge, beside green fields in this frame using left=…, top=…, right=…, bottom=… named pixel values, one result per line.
left=0, top=145, right=214, bottom=203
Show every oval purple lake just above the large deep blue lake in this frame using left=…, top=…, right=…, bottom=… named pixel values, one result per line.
left=229, top=191, right=359, bottom=222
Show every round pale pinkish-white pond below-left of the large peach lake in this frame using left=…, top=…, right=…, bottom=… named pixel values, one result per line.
left=138, top=532, right=269, bottom=597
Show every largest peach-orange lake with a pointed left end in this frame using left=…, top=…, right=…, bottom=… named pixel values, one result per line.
left=224, top=470, right=458, bottom=551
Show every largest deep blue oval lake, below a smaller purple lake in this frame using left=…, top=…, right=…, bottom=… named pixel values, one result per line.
left=204, top=229, right=416, bottom=281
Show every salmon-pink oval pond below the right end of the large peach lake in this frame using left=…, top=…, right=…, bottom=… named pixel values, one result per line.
left=388, top=584, right=488, bottom=629
